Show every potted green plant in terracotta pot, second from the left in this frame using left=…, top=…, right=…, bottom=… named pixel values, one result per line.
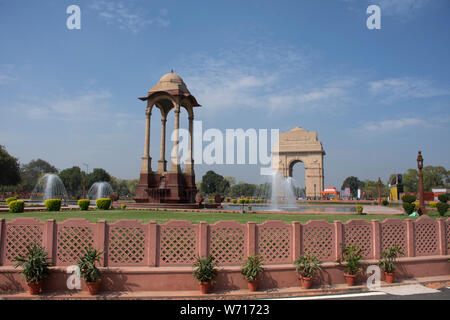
left=77, top=247, right=103, bottom=295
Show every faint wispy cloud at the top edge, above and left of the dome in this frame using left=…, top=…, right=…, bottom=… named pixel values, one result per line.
left=90, top=0, right=170, bottom=33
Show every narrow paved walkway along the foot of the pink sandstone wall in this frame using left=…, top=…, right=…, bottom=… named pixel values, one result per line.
left=0, top=275, right=450, bottom=300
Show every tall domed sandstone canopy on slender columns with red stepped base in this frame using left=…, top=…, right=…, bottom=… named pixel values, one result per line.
left=134, top=70, right=200, bottom=203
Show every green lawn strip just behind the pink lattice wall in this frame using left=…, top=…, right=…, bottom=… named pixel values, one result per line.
left=0, top=209, right=450, bottom=223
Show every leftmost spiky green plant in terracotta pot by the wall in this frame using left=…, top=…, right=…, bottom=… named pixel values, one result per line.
left=14, top=243, right=50, bottom=295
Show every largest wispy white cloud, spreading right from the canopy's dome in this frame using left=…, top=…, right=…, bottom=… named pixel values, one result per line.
left=175, top=40, right=355, bottom=115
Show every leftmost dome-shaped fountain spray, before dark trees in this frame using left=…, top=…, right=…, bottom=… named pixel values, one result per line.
left=30, top=173, right=68, bottom=202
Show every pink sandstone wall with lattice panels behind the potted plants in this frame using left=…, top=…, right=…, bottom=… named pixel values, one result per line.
left=0, top=217, right=450, bottom=291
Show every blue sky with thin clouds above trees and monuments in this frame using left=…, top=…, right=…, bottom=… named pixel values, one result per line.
left=0, top=0, right=450, bottom=188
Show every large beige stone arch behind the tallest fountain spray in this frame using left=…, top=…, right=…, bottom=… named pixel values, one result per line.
left=272, top=127, right=325, bottom=199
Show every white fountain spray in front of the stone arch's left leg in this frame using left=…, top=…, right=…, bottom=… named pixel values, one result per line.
left=271, top=172, right=297, bottom=211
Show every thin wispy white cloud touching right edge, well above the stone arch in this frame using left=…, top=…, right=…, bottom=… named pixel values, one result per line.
left=369, top=77, right=450, bottom=103
